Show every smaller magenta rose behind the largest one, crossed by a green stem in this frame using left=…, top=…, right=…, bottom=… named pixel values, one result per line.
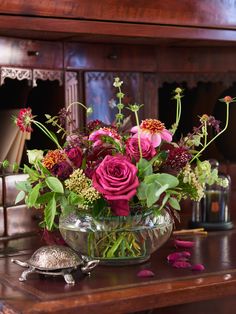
left=126, top=137, right=156, bottom=162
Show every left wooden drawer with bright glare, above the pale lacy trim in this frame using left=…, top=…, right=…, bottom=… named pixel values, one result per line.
left=0, top=37, right=63, bottom=69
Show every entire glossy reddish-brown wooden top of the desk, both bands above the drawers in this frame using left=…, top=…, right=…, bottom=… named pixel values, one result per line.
left=0, top=0, right=236, bottom=46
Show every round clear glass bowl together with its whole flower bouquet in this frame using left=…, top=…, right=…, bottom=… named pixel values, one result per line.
left=15, top=77, right=235, bottom=265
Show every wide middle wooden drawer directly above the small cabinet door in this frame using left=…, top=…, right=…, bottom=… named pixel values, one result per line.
left=65, top=43, right=156, bottom=72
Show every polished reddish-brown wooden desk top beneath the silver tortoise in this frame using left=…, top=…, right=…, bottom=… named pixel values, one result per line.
left=0, top=226, right=236, bottom=314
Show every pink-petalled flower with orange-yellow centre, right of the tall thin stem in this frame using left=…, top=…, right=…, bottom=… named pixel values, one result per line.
left=131, top=119, right=172, bottom=147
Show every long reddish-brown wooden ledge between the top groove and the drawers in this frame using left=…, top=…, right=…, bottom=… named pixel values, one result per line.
left=0, top=15, right=236, bottom=46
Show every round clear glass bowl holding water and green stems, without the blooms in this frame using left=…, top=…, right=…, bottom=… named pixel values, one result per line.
left=59, top=210, right=173, bottom=265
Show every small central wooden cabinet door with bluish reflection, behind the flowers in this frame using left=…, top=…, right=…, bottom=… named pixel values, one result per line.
left=84, top=72, right=158, bottom=124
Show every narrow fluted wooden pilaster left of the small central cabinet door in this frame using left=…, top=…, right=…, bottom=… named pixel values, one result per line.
left=65, top=72, right=80, bottom=131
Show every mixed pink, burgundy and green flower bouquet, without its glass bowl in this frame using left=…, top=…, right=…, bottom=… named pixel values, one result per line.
left=15, top=77, right=236, bottom=260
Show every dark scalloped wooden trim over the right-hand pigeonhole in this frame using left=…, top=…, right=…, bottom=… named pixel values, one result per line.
left=157, top=72, right=236, bottom=88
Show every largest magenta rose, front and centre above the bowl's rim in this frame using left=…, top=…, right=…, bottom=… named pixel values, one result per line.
left=92, top=155, right=139, bottom=216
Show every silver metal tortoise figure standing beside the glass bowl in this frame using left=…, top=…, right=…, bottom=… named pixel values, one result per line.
left=11, top=245, right=99, bottom=285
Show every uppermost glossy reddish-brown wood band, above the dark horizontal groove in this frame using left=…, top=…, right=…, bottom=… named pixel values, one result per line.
left=0, top=0, right=236, bottom=29
